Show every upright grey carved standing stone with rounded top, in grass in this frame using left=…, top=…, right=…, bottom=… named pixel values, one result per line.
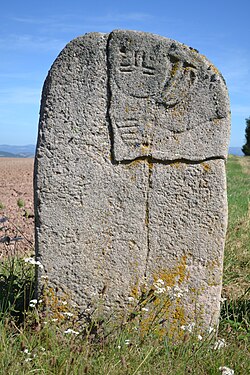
left=35, top=30, right=230, bottom=334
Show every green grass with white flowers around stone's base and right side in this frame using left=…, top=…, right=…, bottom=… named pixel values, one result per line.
left=0, top=157, right=250, bottom=375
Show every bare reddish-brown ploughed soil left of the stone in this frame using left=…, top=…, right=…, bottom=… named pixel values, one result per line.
left=0, top=158, right=34, bottom=259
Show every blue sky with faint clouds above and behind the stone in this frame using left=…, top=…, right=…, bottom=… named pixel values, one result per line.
left=0, top=0, right=250, bottom=146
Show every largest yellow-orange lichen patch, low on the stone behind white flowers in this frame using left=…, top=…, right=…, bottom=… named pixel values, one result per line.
left=127, top=256, right=189, bottom=340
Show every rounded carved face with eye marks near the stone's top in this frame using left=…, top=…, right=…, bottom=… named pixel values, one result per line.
left=109, top=35, right=200, bottom=107
